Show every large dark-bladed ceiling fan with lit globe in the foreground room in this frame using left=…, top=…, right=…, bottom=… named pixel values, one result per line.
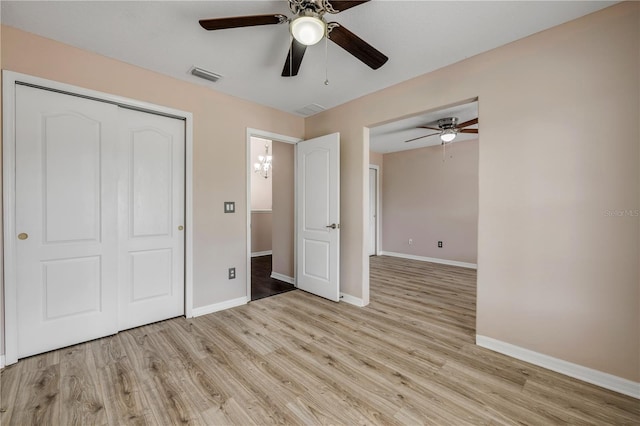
left=200, top=0, right=389, bottom=77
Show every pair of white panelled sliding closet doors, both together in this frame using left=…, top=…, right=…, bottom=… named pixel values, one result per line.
left=15, top=85, right=184, bottom=358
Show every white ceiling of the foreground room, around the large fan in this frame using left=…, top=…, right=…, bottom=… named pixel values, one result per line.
left=1, top=0, right=614, bottom=118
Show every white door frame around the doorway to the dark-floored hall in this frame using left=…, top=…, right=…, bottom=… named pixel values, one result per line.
left=245, top=127, right=304, bottom=302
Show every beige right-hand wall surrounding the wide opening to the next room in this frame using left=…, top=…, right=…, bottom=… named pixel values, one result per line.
left=306, top=2, right=640, bottom=381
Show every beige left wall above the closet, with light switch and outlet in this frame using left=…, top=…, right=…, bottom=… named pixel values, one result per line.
left=2, top=26, right=304, bottom=330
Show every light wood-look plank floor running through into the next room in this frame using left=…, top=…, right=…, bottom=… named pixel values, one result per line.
left=0, top=257, right=640, bottom=425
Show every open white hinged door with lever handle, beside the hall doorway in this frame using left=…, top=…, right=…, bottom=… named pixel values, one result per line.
left=296, top=133, right=340, bottom=302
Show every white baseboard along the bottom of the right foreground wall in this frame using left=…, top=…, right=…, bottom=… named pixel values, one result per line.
left=476, top=334, right=640, bottom=399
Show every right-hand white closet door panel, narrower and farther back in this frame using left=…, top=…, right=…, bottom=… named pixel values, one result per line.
left=118, top=109, right=185, bottom=330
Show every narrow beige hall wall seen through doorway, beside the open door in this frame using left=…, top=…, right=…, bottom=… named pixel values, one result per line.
left=272, top=141, right=295, bottom=277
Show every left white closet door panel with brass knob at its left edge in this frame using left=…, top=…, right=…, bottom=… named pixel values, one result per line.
left=13, top=86, right=118, bottom=357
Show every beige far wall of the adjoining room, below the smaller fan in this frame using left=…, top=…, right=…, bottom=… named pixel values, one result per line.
left=382, top=140, right=478, bottom=263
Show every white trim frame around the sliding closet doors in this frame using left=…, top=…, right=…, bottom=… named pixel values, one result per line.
left=0, top=71, right=193, bottom=364
